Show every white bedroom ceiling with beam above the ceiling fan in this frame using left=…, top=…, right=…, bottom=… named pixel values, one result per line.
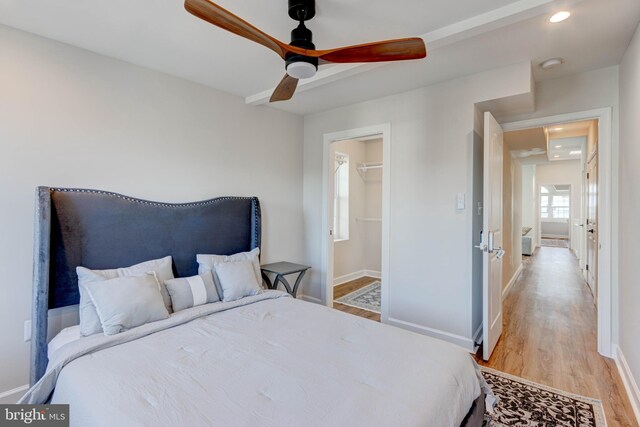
left=0, top=0, right=640, bottom=114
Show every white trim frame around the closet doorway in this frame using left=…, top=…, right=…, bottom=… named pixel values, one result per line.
left=320, top=123, right=391, bottom=322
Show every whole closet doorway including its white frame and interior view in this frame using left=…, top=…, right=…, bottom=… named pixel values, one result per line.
left=322, top=125, right=389, bottom=321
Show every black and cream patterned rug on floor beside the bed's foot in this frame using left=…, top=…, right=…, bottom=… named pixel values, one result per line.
left=481, top=367, right=607, bottom=427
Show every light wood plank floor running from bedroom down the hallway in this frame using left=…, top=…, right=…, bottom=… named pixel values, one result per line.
left=478, top=247, right=637, bottom=427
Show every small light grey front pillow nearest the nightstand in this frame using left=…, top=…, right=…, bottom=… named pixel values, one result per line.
left=215, top=261, right=262, bottom=302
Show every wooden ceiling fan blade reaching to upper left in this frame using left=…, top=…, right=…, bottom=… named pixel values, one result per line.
left=184, top=0, right=289, bottom=59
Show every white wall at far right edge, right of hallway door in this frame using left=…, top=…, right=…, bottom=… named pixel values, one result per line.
left=619, top=20, right=640, bottom=421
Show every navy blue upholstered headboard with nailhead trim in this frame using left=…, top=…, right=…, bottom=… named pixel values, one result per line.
left=31, top=187, right=261, bottom=385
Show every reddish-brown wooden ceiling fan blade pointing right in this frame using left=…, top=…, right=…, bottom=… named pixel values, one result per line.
left=314, top=37, right=427, bottom=63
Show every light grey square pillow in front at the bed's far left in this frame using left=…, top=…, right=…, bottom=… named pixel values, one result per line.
left=85, top=273, right=169, bottom=335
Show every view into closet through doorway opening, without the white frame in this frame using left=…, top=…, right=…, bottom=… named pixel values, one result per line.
left=329, top=135, right=383, bottom=320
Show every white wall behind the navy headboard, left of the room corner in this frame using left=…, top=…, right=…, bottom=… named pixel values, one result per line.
left=0, top=26, right=304, bottom=393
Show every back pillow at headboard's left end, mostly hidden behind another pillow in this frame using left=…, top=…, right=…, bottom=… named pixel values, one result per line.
left=76, top=256, right=173, bottom=337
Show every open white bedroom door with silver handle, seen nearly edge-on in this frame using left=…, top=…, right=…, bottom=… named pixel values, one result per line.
left=480, top=112, right=504, bottom=360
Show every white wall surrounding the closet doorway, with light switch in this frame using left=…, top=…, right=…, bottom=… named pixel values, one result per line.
left=303, top=63, right=531, bottom=348
